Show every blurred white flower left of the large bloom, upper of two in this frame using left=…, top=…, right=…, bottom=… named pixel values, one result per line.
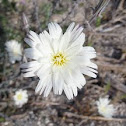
left=5, top=40, right=22, bottom=63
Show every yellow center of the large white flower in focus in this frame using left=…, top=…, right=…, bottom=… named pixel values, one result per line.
left=52, top=52, right=67, bottom=66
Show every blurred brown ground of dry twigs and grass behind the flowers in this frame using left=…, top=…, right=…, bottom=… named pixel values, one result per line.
left=0, top=0, right=126, bottom=126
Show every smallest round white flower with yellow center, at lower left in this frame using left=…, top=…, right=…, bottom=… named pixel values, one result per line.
left=13, top=89, right=28, bottom=107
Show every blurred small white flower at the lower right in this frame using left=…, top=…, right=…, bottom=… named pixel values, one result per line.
left=96, top=97, right=116, bottom=118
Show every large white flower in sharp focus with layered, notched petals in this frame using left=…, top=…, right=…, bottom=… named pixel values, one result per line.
left=21, top=23, right=97, bottom=99
